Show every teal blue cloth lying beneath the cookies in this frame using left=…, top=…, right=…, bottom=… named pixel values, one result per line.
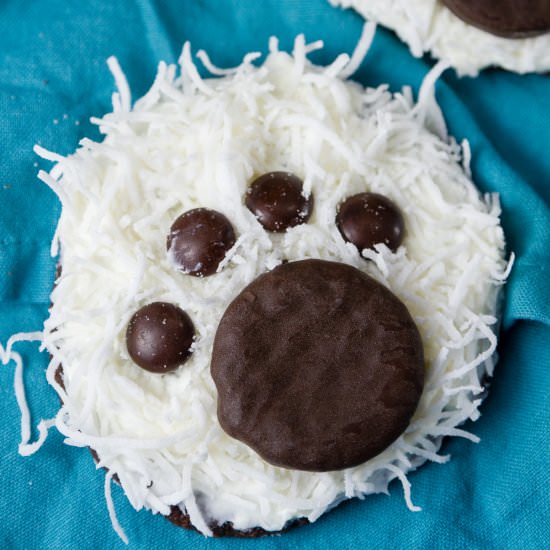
left=0, top=0, right=550, bottom=550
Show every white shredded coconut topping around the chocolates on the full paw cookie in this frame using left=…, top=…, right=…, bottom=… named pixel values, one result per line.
left=4, top=24, right=507, bottom=540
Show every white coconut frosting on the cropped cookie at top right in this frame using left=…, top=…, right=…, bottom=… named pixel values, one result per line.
left=328, top=0, right=550, bottom=76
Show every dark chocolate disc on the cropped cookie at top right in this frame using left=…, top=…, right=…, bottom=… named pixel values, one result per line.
left=443, top=0, right=550, bottom=38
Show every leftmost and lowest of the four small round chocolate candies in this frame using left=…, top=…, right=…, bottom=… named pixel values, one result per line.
left=126, top=302, right=195, bottom=373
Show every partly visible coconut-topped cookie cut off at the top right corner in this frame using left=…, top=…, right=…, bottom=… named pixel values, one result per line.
left=329, top=0, right=550, bottom=76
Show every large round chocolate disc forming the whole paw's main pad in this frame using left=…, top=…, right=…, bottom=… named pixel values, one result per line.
left=211, top=260, right=424, bottom=471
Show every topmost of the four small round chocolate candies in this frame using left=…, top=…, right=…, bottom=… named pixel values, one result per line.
left=246, top=172, right=313, bottom=233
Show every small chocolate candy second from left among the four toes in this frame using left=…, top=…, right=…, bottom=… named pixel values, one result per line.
left=166, top=208, right=235, bottom=277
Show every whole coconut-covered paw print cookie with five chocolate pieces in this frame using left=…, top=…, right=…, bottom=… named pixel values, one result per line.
left=31, top=37, right=507, bottom=536
